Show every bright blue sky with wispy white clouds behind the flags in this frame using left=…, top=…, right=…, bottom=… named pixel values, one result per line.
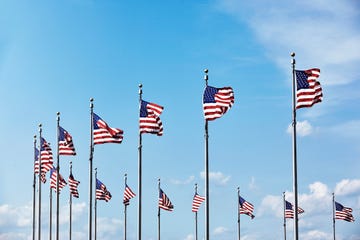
left=0, top=0, right=360, bottom=240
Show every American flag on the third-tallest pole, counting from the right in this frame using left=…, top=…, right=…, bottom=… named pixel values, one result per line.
left=139, top=100, right=164, bottom=136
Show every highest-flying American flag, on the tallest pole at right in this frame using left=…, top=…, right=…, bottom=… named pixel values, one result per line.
left=295, top=68, right=323, bottom=108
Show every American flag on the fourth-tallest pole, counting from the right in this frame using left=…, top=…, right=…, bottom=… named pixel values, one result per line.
left=93, top=113, right=124, bottom=144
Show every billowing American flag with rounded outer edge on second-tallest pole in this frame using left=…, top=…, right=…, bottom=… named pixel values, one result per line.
left=203, top=86, right=234, bottom=121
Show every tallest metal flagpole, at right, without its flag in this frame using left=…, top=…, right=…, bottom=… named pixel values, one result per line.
left=291, top=52, right=299, bottom=240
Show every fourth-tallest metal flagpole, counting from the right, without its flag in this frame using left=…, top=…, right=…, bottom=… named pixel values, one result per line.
left=88, top=98, right=94, bottom=240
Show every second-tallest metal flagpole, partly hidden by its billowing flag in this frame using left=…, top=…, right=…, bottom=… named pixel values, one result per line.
left=204, top=69, right=210, bottom=240
